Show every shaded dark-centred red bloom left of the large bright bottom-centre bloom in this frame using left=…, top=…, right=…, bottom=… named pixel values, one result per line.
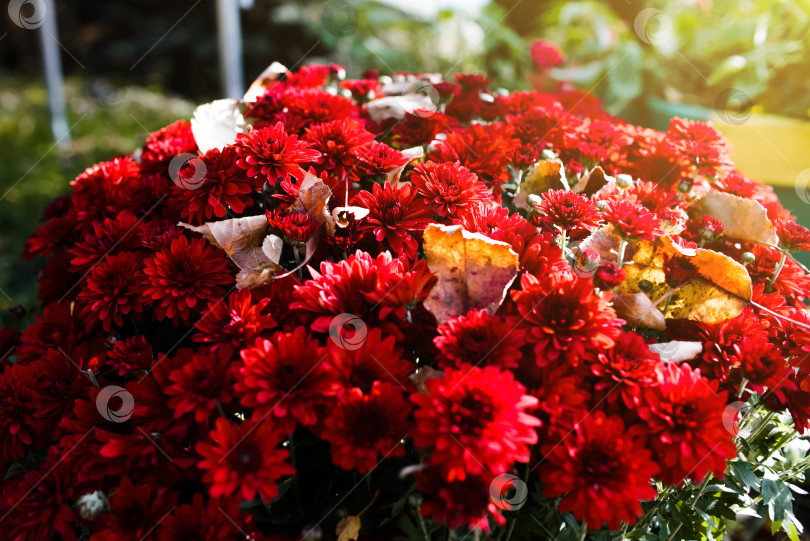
left=321, top=382, right=411, bottom=473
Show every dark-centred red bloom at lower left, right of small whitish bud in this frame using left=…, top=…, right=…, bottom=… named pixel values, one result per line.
left=196, top=417, right=295, bottom=502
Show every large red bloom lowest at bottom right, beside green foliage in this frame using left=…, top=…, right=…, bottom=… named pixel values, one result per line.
left=540, top=411, right=658, bottom=530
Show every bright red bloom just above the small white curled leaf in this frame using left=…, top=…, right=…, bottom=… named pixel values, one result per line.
left=304, top=120, right=374, bottom=179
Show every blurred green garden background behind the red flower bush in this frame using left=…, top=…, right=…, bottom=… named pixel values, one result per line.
left=0, top=0, right=810, bottom=324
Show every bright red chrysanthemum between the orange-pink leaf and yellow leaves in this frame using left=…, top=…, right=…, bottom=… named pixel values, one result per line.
left=512, top=274, right=624, bottom=366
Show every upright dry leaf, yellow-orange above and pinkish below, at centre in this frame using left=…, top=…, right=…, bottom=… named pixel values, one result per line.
left=424, top=224, right=518, bottom=323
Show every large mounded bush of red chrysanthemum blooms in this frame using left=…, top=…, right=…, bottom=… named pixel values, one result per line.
left=0, top=61, right=810, bottom=541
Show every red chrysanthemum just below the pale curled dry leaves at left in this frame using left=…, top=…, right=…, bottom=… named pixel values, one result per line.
left=192, top=290, right=276, bottom=357
